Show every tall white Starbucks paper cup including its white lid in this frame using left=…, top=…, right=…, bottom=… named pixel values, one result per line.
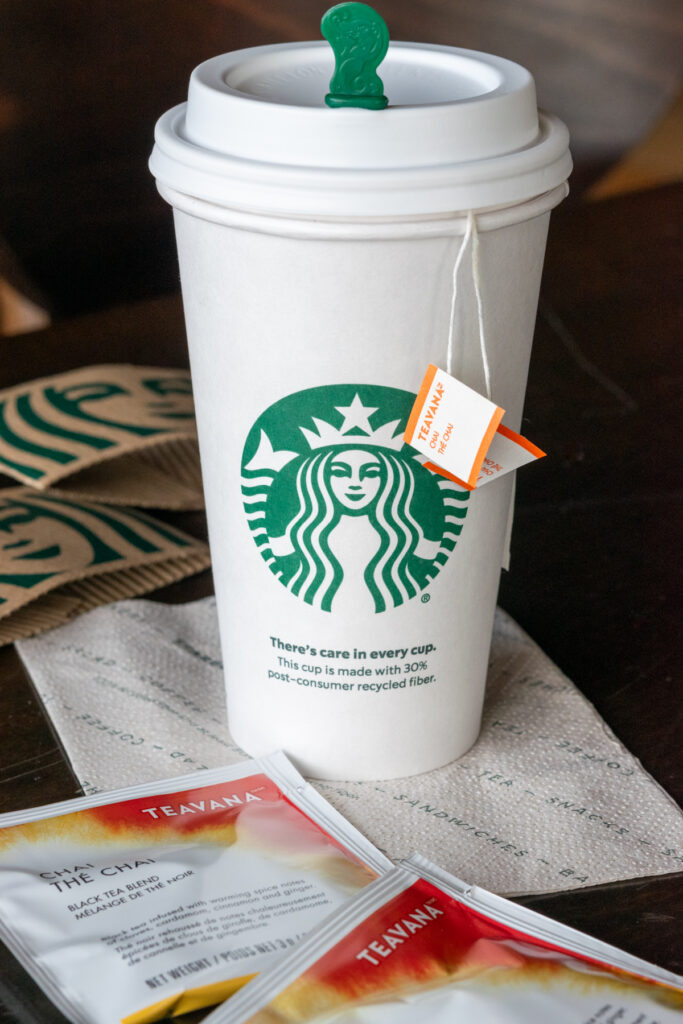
left=151, top=36, right=570, bottom=779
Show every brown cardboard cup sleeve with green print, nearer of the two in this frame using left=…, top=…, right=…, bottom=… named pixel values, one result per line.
left=0, top=487, right=211, bottom=645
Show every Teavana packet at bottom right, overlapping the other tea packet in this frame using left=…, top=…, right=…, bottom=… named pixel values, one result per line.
left=206, top=856, right=683, bottom=1024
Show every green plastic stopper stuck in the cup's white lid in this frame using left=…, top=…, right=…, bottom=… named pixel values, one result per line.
left=321, top=3, right=389, bottom=111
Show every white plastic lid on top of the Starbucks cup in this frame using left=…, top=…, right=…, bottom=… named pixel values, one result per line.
left=150, top=41, right=571, bottom=217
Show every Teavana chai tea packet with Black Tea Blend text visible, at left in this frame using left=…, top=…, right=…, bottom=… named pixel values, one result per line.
left=0, top=754, right=391, bottom=1024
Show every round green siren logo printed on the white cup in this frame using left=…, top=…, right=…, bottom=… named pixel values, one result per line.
left=242, top=384, right=469, bottom=614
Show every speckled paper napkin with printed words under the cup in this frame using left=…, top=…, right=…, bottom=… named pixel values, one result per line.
left=17, top=598, right=683, bottom=895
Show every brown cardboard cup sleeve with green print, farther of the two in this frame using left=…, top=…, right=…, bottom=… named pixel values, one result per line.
left=0, top=364, right=204, bottom=509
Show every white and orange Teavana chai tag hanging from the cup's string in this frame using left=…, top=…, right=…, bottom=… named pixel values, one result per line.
left=403, top=364, right=545, bottom=490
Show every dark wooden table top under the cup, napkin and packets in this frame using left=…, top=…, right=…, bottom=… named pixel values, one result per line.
left=0, top=185, right=683, bottom=1024
